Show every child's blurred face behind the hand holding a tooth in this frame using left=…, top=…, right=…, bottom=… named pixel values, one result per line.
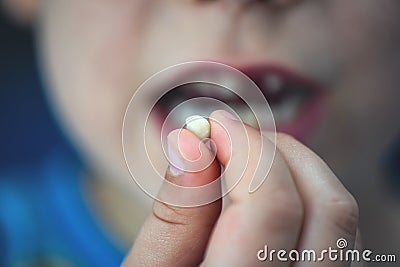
left=39, top=0, right=400, bottom=182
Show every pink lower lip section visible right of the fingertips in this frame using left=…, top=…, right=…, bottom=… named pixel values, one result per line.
left=276, top=93, right=327, bottom=142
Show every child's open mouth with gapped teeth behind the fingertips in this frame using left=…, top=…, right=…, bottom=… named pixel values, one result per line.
left=152, top=64, right=325, bottom=141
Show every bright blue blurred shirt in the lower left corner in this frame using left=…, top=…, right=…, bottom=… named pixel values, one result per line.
left=0, top=148, right=124, bottom=266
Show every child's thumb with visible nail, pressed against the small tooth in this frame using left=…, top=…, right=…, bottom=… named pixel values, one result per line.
left=122, top=129, right=222, bottom=267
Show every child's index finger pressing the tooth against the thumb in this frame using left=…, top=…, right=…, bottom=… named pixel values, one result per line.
left=204, top=111, right=303, bottom=266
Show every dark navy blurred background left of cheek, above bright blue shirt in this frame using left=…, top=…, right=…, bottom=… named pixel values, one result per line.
left=0, top=14, right=63, bottom=172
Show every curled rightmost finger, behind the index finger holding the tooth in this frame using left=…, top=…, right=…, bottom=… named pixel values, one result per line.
left=277, top=135, right=358, bottom=266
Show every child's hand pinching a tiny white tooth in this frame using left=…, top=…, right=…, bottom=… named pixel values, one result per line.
left=124, top=111, right=358, bottom=266
